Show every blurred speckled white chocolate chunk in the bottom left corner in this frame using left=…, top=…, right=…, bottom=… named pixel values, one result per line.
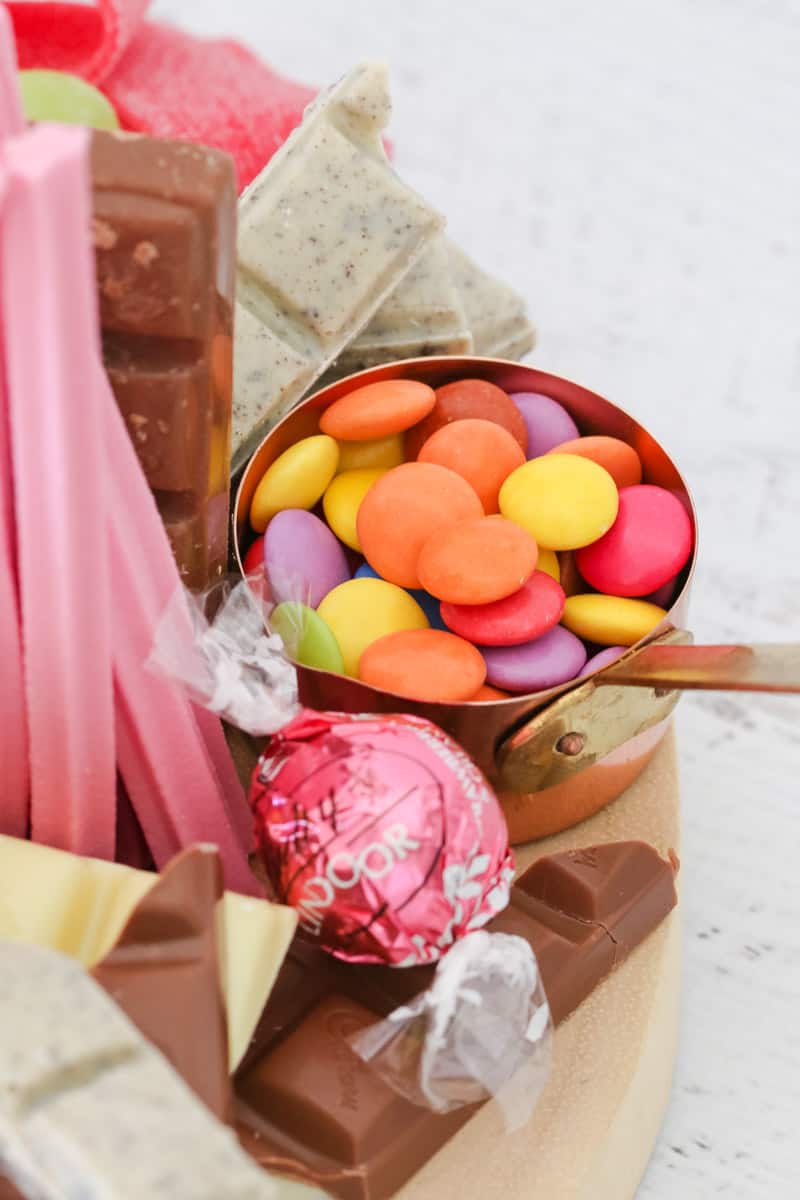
left=0, top=942, right=286, bottom=1200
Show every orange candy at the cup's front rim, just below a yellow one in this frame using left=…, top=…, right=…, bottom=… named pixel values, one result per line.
left=359, top=629, right=486, bottom=703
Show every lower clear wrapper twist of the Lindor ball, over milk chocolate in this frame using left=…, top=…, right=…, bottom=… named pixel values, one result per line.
left=349, top=930, right=553, bottom=1133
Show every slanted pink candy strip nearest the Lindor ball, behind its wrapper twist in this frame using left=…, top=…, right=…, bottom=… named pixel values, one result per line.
left=103, top=372, right=257, bottom=895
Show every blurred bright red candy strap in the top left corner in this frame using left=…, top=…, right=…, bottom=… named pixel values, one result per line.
left=6, top=0, right=150, bottom=83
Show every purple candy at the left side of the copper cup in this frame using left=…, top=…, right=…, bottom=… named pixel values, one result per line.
left=264, top=509, right=350, bottom=608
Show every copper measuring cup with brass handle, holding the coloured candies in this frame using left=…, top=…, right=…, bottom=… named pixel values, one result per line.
left=234, top=356, right=800, bottom=842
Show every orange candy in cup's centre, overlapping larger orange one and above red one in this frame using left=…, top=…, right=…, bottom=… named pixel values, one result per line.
left=417, top=516, right=539, bottom=604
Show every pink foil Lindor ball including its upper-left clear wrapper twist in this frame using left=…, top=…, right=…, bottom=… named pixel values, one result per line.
left=150, top=582, right=513, bottom=966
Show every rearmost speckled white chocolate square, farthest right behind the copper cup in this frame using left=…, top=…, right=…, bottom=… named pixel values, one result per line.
left=446, top=239, right=536, bottom=360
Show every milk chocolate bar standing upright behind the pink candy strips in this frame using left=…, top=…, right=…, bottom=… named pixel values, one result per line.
left=92, top=132, right=236, bottom=589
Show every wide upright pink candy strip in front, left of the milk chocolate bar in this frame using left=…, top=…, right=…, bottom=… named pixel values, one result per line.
left=0, top=126, right=116, bottom=858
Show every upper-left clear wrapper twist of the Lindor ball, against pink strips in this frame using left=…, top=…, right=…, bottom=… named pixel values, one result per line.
left=148, top=580, right=299, bottom=737
